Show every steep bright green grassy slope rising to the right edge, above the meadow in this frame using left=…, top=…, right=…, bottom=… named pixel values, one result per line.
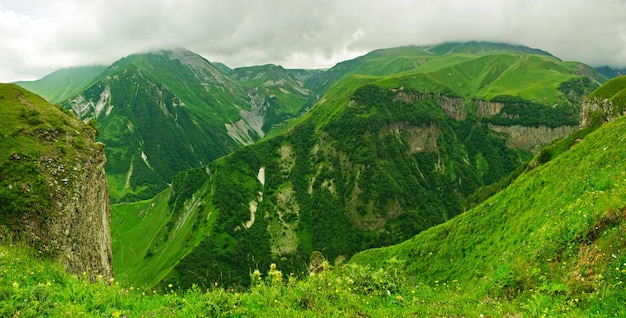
left=351, top=117, right=626, bottom=315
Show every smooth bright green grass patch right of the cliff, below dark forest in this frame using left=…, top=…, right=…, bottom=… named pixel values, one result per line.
left=111, top=188, right=216, bottom=286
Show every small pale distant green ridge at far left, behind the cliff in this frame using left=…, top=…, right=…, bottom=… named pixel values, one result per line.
left=15, top=65, right=106, bottom=104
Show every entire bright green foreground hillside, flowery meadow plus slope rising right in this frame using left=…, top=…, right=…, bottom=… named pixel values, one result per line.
left=0, top=102, right=626, bottom=317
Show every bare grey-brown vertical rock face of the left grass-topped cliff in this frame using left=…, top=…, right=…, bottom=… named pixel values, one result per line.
left=46, top=144, right=113, bottom=279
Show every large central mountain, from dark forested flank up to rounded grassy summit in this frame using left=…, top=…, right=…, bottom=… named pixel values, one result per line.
left=113, top=42, right=596, bottom=286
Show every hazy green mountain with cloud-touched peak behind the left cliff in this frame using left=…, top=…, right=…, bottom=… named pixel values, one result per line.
left=63, top=49, right=308, bottom=202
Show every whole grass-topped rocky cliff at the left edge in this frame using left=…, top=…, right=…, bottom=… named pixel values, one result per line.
left=0, top=84, right=113, bottom=279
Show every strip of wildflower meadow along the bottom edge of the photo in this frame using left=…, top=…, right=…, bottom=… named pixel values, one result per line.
left=0, top=236, right=626, bottom=317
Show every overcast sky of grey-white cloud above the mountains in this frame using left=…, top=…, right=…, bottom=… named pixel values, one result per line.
left=0, top=0, right=626, bottom=82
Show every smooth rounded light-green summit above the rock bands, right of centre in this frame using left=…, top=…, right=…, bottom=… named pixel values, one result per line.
left=311, top=42, right=606, bottom=95
